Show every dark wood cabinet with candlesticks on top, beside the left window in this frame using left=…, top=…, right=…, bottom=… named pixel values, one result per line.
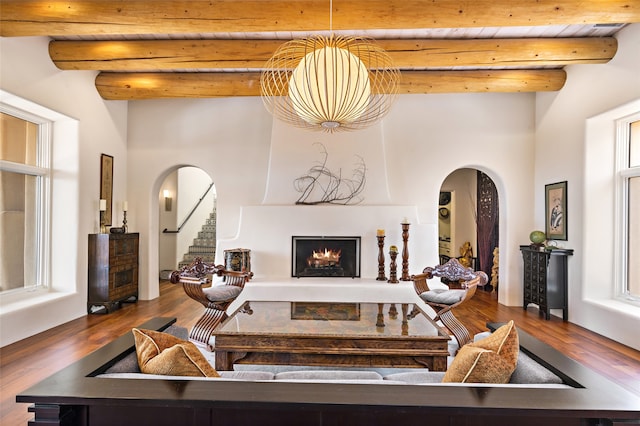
left=87, top=233, right=139, bottom=313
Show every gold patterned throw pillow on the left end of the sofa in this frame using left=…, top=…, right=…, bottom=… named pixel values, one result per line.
left=132, top=328, right=220, bottom=377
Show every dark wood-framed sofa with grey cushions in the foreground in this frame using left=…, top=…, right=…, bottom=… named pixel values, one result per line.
left=16, top=318, right=640, bottom=426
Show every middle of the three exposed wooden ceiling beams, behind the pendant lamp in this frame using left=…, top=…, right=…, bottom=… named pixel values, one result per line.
left=49, top=37, right=617, bottom=71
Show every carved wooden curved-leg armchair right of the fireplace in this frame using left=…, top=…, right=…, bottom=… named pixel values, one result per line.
left=410, top=258, right=489, bottom=347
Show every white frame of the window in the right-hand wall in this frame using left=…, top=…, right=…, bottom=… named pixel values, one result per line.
left=614, top=111, right=640, bottom=306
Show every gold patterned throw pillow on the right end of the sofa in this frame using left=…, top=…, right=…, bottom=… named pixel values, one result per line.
left=442, top=321, right=520, bottom=383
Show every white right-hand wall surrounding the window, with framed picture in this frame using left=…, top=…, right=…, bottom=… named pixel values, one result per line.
left=536, top=24, right=640, bottom=349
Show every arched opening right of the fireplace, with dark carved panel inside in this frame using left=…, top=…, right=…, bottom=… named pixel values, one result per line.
left=438, top=168, right=499, bottom=291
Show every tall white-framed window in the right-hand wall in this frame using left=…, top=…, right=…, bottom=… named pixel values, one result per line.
left=617, top=114, right=640, bottom=302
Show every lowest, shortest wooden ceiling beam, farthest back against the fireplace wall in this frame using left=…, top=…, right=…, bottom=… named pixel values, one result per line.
left=96, top=69, right=566, bottom=100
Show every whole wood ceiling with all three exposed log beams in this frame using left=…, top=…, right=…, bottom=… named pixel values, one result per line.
left=0, top=0, right=640, bottom=100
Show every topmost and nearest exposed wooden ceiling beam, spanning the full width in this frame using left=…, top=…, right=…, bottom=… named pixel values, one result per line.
left=0, top=0, right=640, bottom=37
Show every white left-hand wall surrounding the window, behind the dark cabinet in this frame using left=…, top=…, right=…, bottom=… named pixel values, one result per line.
left=0, top=37, right=127, bottom=346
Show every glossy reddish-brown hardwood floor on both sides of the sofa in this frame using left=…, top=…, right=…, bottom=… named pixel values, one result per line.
left=0, top=282, right=640, bottom=425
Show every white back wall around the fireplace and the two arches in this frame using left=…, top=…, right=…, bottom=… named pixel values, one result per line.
left=129, top=94, right=534, bottom=304
